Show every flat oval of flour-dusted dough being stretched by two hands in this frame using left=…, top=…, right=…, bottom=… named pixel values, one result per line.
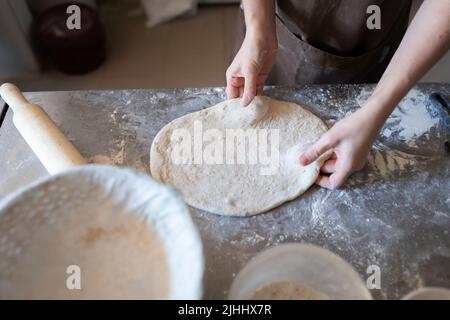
left=150, top=96, right=330, bottom=216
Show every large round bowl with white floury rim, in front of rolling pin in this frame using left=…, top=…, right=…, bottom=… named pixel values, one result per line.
left=0, top=165, right=203, bottom=299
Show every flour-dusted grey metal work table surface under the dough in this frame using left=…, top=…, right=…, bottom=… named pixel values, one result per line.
left=0, top=84, right=450, bottom=299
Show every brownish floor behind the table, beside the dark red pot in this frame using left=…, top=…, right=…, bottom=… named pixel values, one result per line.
left=9, top=2, right=239, bottom=91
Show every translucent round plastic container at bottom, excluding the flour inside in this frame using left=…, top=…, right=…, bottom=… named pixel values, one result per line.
left=228, top=243, right=372, bottom=300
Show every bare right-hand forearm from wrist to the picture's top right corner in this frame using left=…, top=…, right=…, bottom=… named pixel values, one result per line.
left=366, top=0, right=450, bottom=121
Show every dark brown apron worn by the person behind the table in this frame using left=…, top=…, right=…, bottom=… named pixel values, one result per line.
left=234, top=0, right=411, bottom=85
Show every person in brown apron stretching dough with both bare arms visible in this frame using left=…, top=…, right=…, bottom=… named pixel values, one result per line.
left=226, top=0, right=450, bottom=188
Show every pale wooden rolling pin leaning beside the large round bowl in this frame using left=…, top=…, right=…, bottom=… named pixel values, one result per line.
left=0, top=83, right=87, bottom=174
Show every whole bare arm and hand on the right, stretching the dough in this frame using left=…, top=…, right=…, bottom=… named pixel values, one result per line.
left=300, top=0, right=450, bottom=189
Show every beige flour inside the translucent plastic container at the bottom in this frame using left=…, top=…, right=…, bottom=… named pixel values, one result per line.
left=250, top=281, right=328, bottom=300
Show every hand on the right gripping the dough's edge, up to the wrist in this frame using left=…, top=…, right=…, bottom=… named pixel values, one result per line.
left=300, top=106, right=384, bottom=189
